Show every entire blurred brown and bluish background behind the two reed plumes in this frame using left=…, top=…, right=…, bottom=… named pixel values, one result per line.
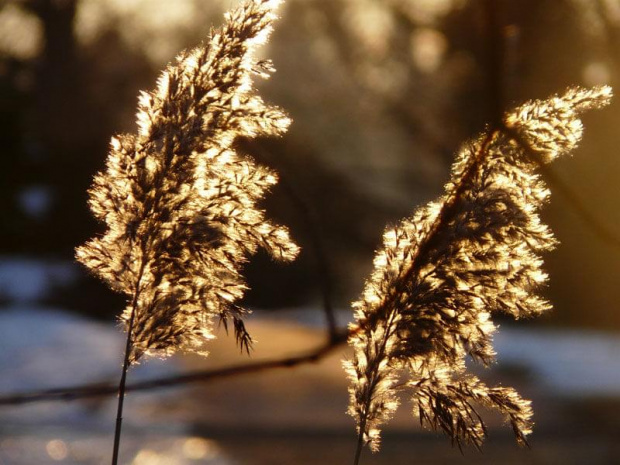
left=0, top=0, right=620, bottom=465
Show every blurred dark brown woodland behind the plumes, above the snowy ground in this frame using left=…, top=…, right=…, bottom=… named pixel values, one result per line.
left=0, top=0, right=620, bottom=329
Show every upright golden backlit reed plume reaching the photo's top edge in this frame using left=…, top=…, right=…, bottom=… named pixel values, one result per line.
left=77, top=0, right=298, bottom=363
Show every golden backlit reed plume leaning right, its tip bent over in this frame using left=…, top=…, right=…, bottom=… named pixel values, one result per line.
left=345, top=87, right=611, bottom=456
